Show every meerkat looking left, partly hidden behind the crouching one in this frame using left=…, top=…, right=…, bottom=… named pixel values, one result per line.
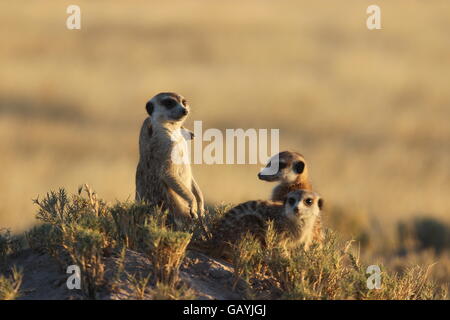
left=258, top=151, right=324, bottom=243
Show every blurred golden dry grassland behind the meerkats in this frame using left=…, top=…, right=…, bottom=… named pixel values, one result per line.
left=0, top=0, right=450, bottom=284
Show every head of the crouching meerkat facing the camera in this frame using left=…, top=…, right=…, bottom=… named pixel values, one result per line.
left=284, top=190, right=323, bottom=220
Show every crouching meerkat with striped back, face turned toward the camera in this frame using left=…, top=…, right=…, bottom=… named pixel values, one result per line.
left=210, top=190, right=323, bottom=259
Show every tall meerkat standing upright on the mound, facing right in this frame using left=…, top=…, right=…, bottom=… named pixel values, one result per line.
left=136, top=92, right=204, bottom=226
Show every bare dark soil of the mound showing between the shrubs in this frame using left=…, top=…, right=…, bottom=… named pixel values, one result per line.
left=4, top=250, right=243, bottom=300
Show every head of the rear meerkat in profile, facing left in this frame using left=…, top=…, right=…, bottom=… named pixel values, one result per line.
left=258, top=151, right=308, bottom=184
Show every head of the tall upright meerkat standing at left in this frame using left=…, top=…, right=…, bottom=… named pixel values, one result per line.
left=146, top=92, right=190, bottom=126
